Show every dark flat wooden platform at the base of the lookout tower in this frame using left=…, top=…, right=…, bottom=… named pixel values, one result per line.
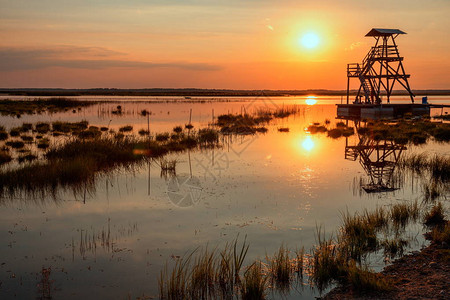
left=336, top=103, right=436, bottom=119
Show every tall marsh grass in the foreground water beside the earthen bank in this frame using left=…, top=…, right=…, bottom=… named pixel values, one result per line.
left=160, top=202, right=428, bottom=299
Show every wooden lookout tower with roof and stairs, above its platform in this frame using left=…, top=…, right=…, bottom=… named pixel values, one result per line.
left=347, top=28, right=414, bottom=104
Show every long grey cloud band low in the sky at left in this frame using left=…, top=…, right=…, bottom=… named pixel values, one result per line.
left=0, top=46, right=221, bottom=72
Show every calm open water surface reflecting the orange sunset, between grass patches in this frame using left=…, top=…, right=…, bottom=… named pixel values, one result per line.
left=0, top=97, right=450, bottom=299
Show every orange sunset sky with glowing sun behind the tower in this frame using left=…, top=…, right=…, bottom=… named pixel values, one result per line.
left=0, top=0, right=450, bottom=90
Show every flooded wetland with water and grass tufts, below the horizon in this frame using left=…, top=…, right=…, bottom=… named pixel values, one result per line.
left=0, top=95, right=450, bottom=299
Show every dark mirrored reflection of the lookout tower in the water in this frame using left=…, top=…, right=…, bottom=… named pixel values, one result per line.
left=345, top=122, right=406, bottom=193
